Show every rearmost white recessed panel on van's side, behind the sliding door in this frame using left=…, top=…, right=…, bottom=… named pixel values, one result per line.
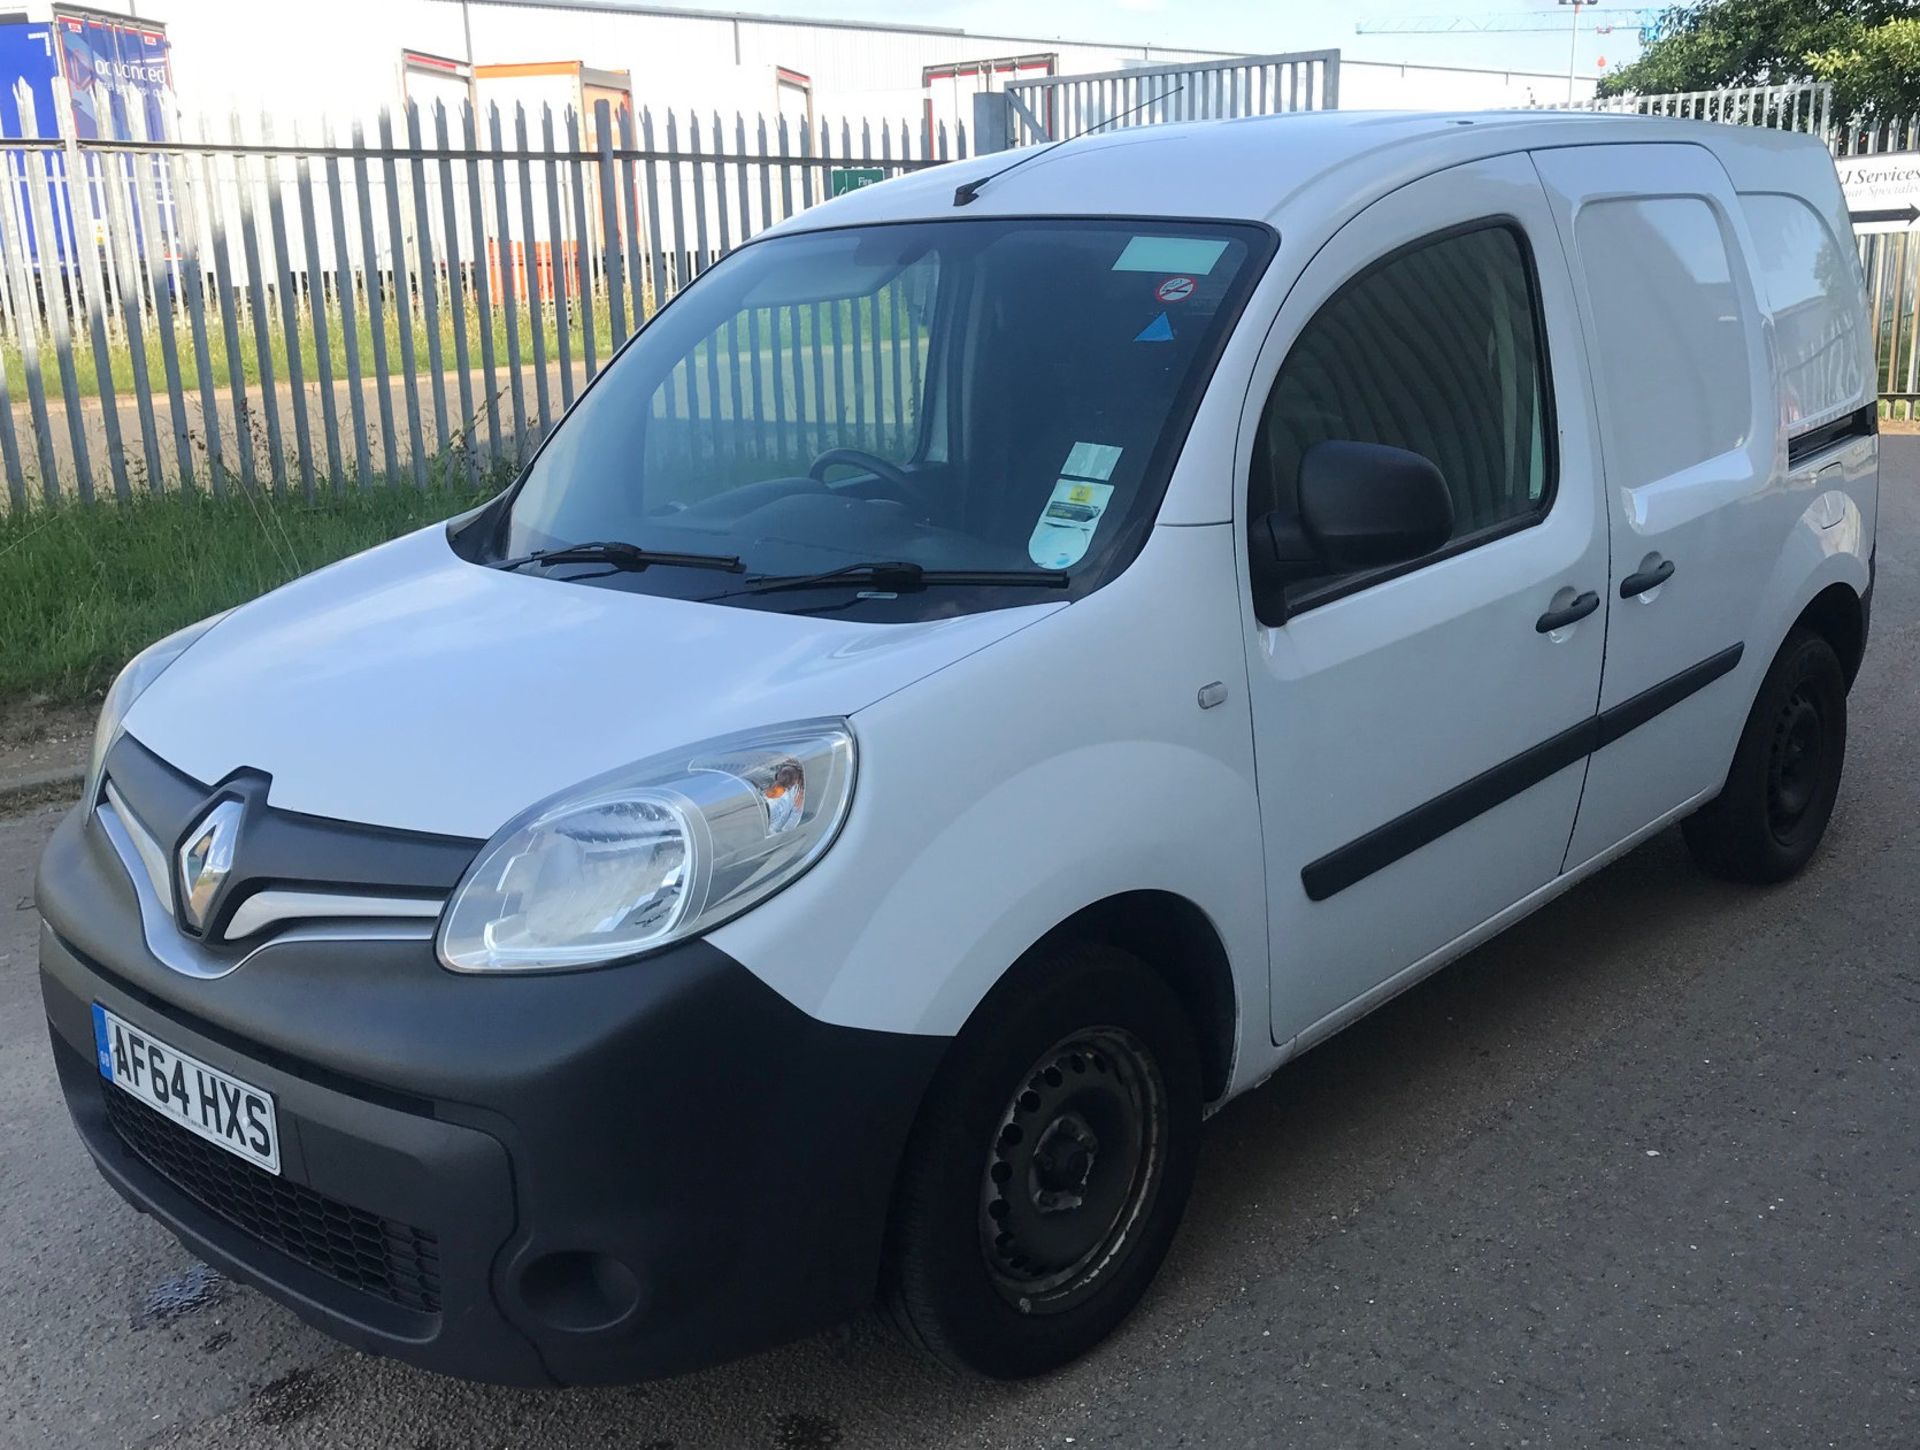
left=1740, top=192, right=1870, bottom=432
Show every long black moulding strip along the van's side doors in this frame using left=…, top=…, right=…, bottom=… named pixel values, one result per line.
left=1300, top=643, right=1747, bottom=901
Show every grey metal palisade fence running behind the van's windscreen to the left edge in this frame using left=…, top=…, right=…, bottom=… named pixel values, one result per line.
left=0, top=96, right=968, bottom=509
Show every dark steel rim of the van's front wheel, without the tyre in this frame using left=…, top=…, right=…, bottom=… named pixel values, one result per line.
left=979, top=1027, right=1169, bottom=1314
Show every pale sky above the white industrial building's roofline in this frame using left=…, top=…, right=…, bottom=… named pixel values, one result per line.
left=702, top=0, right=1640, bottom=77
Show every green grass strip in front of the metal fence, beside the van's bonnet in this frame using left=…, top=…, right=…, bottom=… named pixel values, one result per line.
left=0, top=486, right=492, bottom=703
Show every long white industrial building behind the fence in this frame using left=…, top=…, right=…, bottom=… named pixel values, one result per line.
left=3, top=0, right=1594, bottom=136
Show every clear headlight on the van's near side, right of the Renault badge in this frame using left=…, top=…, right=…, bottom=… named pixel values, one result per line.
left=440, top=720, right=854, bottom=972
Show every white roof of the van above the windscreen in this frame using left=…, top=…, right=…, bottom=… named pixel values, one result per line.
left=776, top=111, right=1837, bottom=232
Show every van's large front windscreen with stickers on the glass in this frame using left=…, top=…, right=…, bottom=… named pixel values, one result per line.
left=486, top=219, right=1273, bottom=618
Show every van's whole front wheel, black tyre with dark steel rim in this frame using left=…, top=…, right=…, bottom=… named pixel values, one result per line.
left=883, top=945, right=1200, bottom=1379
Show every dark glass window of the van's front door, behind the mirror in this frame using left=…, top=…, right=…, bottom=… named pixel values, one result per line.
left=1248, top=223, right=1553, bottom=592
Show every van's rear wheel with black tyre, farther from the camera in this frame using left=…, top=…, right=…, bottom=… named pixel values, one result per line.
left=1682, top=628, right=1847, bottom=883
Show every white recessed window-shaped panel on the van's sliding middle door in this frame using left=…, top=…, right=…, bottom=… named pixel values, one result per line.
left=1576, top=196, right=1753, bottom=488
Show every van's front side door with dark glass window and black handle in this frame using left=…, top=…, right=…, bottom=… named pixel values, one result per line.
left=1240, top=156, right=1607, bottom=1047
